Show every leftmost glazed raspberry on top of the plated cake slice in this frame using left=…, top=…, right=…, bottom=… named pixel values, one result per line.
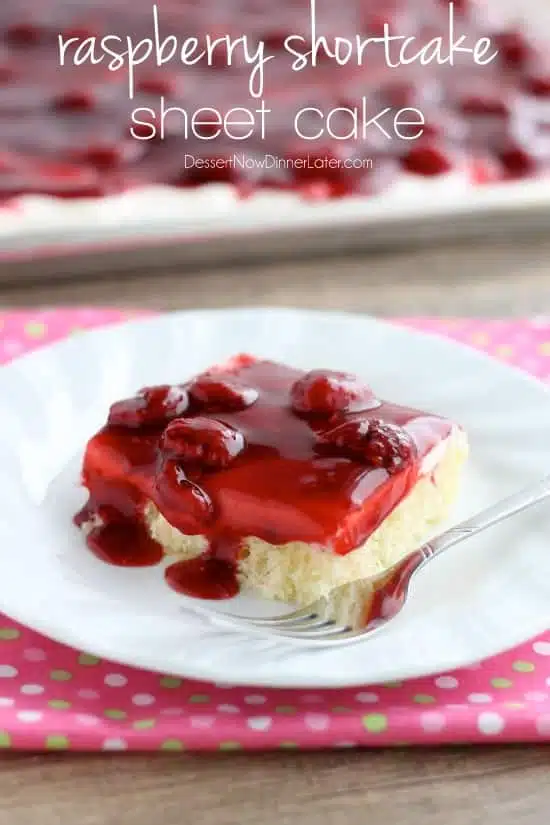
left=108, top=384, right=189, bottom=429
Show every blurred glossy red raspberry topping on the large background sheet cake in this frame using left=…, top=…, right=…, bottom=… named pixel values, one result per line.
left=0, top=0, right=550, bottom=199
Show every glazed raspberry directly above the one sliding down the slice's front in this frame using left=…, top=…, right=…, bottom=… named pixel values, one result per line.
left=161, top=416, right=245, bottom=470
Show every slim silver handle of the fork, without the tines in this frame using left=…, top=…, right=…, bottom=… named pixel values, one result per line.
left=426, top=476, right=550, bottom=557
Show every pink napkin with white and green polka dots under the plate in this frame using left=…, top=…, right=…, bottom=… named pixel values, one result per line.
left=0, top=308, right=550, bottom=751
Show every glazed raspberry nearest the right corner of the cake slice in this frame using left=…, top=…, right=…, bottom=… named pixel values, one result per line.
left=321, top=418, right=416, bottom=473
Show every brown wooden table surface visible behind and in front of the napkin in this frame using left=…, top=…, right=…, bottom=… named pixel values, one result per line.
left=0, top=237, right=550, bottom=825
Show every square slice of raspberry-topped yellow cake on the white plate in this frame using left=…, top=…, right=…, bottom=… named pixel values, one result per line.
left=75, top=355, right=467, bottom=605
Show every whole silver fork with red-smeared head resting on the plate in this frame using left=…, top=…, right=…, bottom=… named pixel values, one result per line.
left=211, top=476, right=550, bottom=647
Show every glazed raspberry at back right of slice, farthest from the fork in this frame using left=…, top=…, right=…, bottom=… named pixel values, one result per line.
left=290, top=370, right=380, bottom=416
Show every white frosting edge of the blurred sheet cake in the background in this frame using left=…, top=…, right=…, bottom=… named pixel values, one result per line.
left=0, top=168, right=550, bottom=253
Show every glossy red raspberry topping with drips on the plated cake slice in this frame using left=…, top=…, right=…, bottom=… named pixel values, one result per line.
left=76, top=356, right=458, bottom=598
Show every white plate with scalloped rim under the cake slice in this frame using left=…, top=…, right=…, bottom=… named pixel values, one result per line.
left=0, top=309, right=550, bottom=687
